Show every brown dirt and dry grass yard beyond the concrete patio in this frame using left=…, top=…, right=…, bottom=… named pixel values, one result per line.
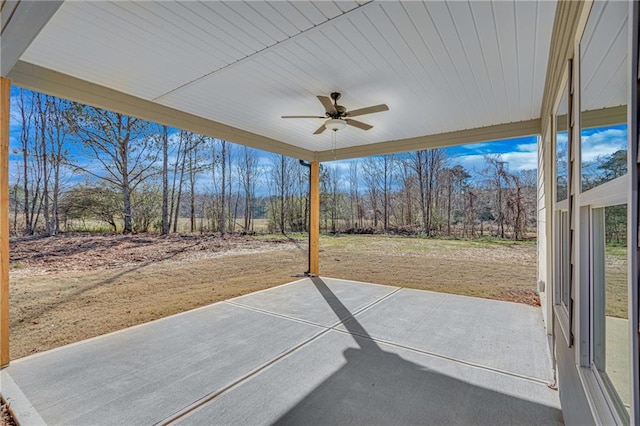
left=10, top=234, right=539, bottom=359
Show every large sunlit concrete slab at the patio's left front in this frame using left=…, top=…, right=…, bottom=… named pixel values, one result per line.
left=8, top=303, right=321, bottom=425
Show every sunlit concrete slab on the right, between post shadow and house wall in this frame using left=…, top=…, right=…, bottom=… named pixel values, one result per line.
left=339, top=289, right=553, bottom=382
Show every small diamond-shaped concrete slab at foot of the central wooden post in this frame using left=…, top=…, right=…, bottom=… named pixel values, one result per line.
left=229, top=278, right=399, bottom=327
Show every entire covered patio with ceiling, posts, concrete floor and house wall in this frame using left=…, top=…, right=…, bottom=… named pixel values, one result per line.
left=0, top=0, right=640, bottom=424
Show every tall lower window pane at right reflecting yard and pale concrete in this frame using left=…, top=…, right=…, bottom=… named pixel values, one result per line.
left=592, top=205, right=631, bottom=416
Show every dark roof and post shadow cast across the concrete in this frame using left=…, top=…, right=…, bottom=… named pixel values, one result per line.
left=275, top=278, right=563, bottom=425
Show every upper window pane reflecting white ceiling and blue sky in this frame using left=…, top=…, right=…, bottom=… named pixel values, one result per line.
left=580, top=1, right=629, bottom=191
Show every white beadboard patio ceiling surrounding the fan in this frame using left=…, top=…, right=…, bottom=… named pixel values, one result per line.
left=20, top=0, right=556, bottom=151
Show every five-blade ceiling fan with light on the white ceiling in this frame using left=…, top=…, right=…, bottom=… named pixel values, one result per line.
left=282, top=92, right=389, bottom=135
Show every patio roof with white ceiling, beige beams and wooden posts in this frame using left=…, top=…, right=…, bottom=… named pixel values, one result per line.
left=0, top=0, right=559, bottom=366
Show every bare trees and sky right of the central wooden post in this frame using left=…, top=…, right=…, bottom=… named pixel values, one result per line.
left=321, top=149, right=536, bottom=239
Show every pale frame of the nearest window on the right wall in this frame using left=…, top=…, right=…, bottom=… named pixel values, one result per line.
left=573, top=2, right=640, bottom=424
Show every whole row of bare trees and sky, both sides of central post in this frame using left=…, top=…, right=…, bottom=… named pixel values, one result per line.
left=11, top=90, right=536, bottom=238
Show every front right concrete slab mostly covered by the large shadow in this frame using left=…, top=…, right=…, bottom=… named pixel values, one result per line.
left=178, top=331, right=562, bottom=425
